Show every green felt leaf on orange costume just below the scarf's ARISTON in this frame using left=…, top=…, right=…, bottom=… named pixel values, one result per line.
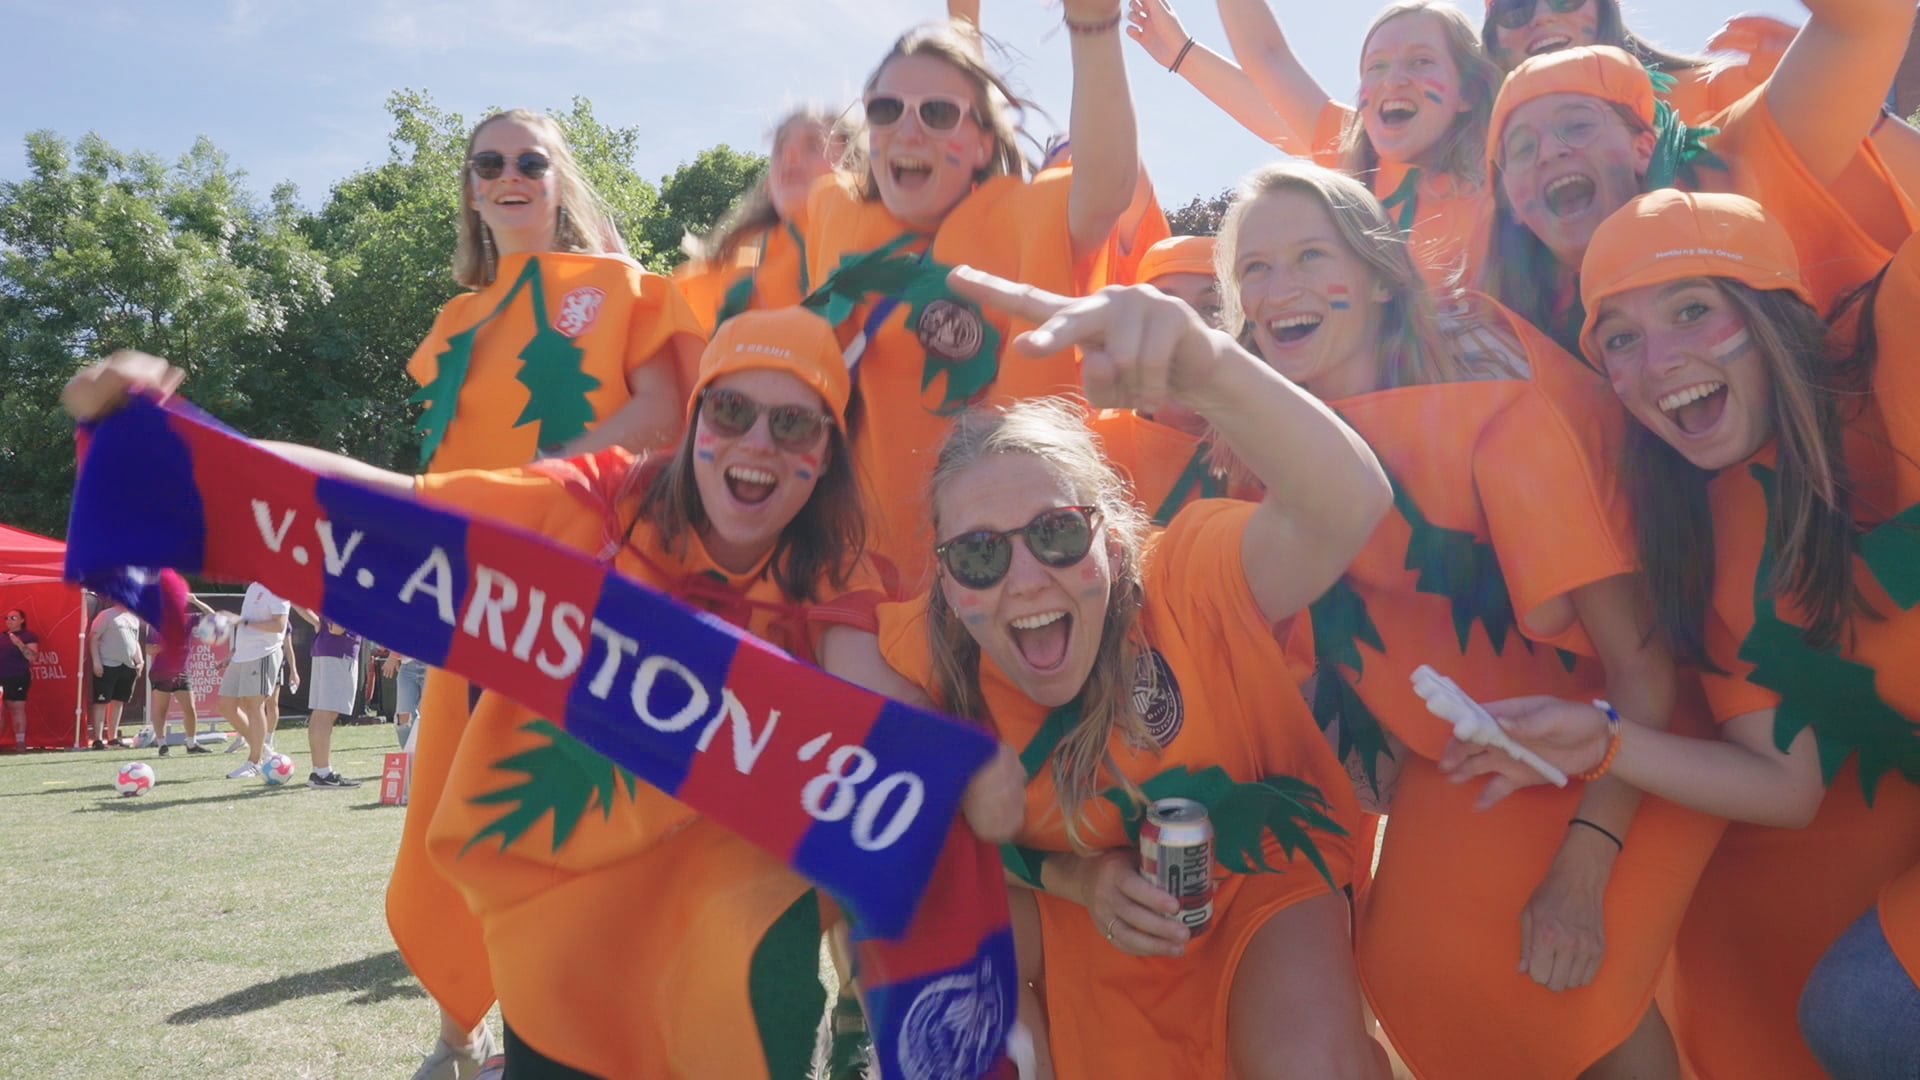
left=461, top=719, right=636, bottom=851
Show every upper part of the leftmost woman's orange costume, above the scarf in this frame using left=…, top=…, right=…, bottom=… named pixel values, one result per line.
left=407, top=252, right=705, bottom=473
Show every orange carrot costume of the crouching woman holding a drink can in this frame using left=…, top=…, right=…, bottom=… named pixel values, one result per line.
left=879, top=502, right=1359, bottom=1080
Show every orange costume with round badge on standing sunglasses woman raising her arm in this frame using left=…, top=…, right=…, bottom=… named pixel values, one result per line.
left=794, top=169, right=1087, bottom=586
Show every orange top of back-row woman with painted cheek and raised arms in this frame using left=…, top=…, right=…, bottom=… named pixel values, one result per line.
left=1313, top=102, right=1494, bottom=292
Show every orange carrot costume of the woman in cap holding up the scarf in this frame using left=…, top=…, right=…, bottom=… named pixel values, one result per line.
left=417, top=450, right=883, bottom=1076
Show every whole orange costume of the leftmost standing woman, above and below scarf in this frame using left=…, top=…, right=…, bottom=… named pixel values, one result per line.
left=386, top=252, right=701, bottom=1028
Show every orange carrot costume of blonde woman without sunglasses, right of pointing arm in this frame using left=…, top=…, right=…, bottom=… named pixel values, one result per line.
left=1311, top=305, right=1724, bottom=1078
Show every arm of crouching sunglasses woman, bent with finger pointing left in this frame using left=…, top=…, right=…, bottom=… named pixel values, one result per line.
left=952, top=267, right=1392, bottom=623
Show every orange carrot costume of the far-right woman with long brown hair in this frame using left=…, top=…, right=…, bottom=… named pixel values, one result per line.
left=1674, top=222, right=1920, bottom=1080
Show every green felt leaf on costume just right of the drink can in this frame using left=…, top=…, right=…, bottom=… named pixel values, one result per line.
left=1102, top=765, right=1346, bottom=886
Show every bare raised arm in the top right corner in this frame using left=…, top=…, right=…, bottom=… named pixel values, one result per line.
left=1763, top=0, right=1914, bottom=183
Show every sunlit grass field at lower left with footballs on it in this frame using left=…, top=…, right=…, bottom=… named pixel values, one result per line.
left=0, top=724, right=480, bottom=1080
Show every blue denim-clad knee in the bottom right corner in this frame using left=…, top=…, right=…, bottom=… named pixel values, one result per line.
left=1799, top=909, right=1920, bottom=1080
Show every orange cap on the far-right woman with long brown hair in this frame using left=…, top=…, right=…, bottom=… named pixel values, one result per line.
left=1580, top=188, right=1812, bottom=363
